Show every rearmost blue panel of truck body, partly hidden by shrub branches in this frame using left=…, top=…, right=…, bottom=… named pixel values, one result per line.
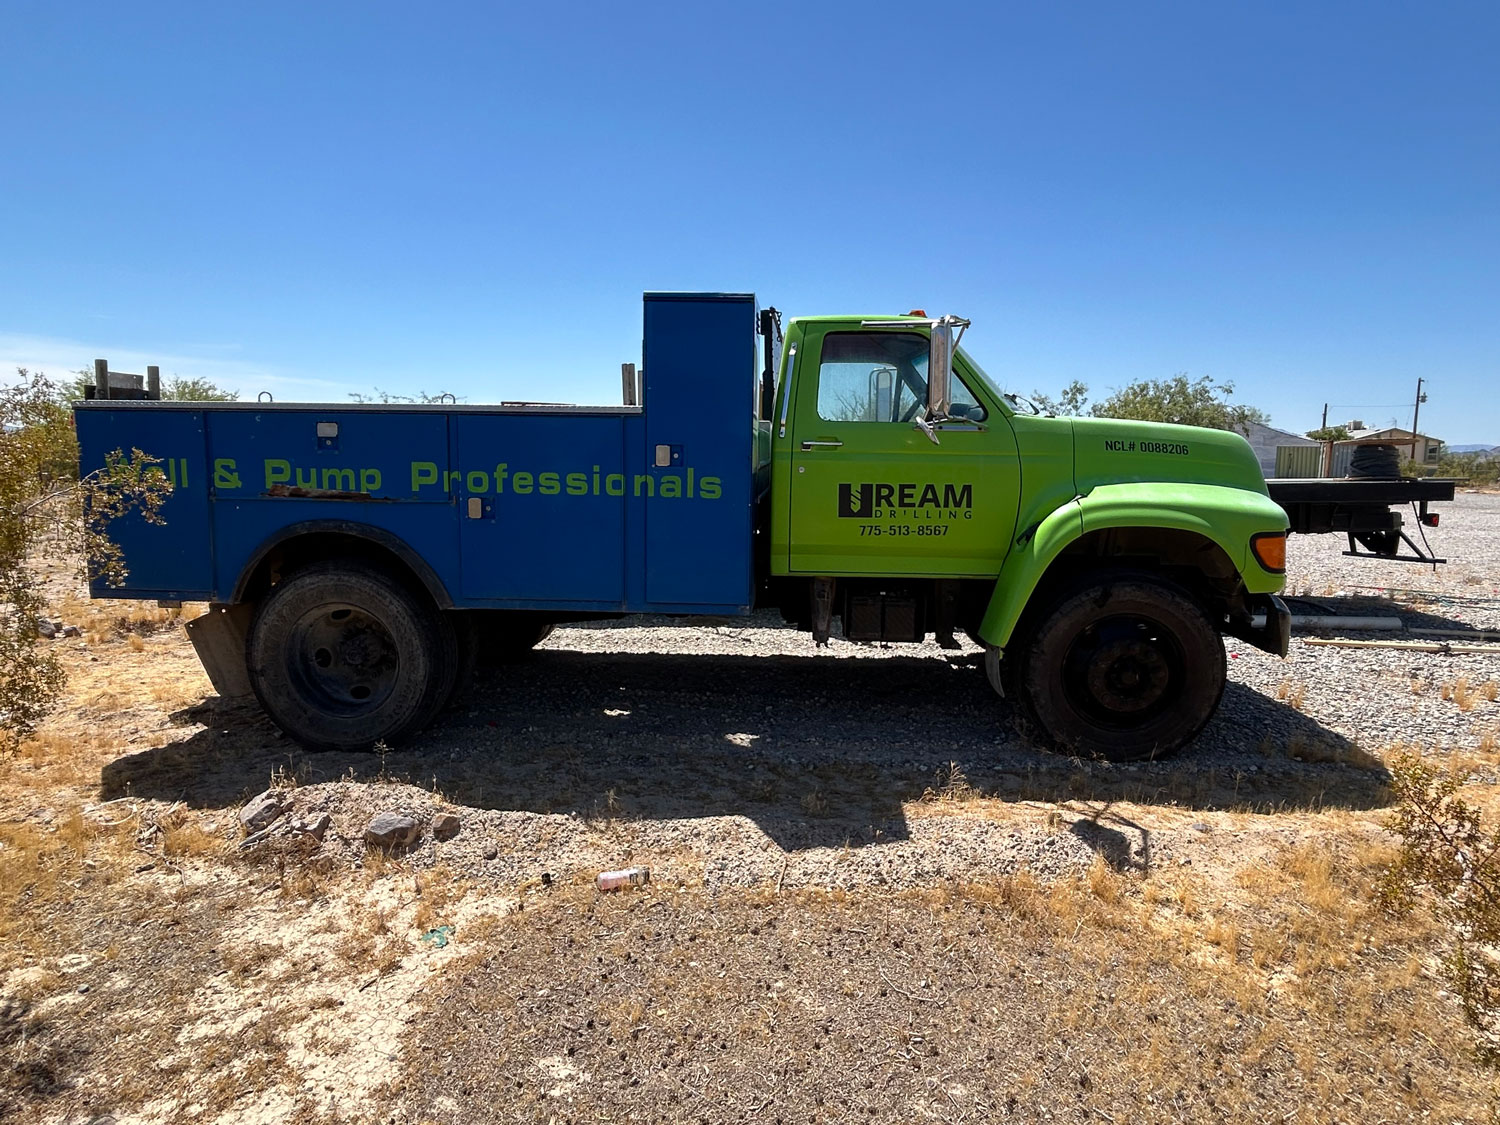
left=77, top=410, right=213, bottom=599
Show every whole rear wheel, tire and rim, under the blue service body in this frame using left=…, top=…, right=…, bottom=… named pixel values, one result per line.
left=246, top=561, right=444, bottom=750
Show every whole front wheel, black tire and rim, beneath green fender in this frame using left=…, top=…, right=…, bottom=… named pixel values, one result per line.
left=1002, top=572, right=1226, bottom=762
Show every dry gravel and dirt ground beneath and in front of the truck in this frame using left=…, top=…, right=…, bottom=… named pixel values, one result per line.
left=11, top=495, right=1500, bottom=1125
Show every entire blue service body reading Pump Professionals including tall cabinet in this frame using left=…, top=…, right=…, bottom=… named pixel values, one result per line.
left=77, top=293, right=759, bottom=615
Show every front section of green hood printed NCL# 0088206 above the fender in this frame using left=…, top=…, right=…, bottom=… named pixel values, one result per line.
left=1071, top=419, right=1268, bottom=497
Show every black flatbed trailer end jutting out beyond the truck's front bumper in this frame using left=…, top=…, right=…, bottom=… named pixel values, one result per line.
left=1266, top=477, right=1458, bottom=566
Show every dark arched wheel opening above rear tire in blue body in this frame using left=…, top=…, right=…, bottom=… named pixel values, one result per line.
left=230, top=519, right=453, bottom=609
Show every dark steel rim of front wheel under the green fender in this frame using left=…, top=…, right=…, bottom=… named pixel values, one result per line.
left=1062, top=614, right=1187, bottom=731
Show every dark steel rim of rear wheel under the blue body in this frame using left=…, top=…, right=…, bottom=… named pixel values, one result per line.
left=288, top=603, right=401, bottom=714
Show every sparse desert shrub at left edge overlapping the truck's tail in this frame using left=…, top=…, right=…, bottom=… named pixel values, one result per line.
left=0, top=368, right=171, bottom=747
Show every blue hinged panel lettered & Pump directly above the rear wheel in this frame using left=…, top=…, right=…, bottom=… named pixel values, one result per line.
left=209, top=407, right=453, bottom=504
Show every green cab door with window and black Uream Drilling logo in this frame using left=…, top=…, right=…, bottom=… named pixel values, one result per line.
left=789, top=324, right=1020, bottom=578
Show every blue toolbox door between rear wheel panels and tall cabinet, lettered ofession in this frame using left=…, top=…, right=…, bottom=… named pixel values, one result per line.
left=453, top=414, right=630, bottom=609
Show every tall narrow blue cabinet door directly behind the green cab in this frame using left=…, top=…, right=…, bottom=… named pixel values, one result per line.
left=632, top=293, right=758, bottom=609
